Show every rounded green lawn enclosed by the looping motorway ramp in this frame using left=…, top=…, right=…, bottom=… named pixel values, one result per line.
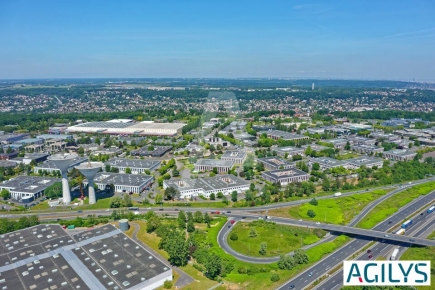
left=228, top=221, right=325, bottom=257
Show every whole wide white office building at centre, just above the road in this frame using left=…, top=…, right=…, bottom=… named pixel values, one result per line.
left=163, top=174, right=249, bottom=198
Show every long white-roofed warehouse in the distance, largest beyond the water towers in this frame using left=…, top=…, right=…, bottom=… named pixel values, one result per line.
left=68, top=120, right=185, bottom=136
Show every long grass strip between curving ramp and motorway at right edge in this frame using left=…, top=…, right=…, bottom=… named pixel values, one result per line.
left=356, top=182, right=435, bottom=229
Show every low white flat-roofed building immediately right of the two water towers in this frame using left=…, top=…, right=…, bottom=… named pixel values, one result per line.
left=89, top=172, right=154, bottom=193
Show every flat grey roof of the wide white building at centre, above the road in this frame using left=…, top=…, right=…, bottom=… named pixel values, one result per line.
left=164, top=174, right=249, bottom=191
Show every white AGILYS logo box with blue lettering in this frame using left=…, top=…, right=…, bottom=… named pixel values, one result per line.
left=343, top=261, right=430, bottom=286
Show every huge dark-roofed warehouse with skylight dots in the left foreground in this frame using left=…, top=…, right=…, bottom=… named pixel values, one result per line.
left=0, top=224, right=172, bottom=290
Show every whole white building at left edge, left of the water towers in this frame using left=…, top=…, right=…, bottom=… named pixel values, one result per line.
left=0, top=176, right=60, bottom=203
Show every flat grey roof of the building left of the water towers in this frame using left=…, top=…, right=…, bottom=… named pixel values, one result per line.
left=0, top=176, right=61, bottom=194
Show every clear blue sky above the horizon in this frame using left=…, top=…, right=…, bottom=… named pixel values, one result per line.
left=0, top=0, right=435, bottom=81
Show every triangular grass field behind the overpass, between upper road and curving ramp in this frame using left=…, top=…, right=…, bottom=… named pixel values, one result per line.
left=268, top=189, right=387, bottom=225
